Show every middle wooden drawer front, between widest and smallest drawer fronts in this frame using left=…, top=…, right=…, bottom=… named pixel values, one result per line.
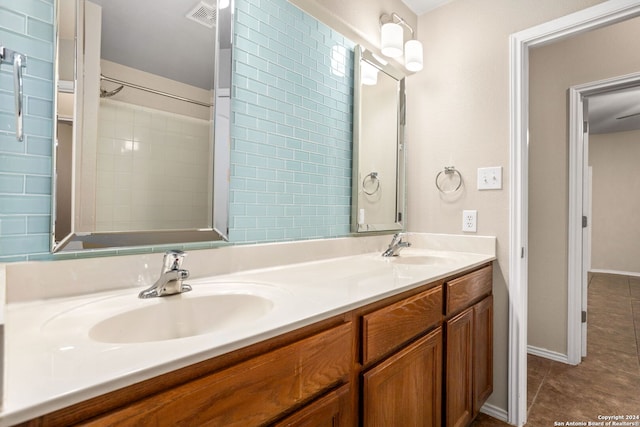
left=362, top=286, right=442, bottom=365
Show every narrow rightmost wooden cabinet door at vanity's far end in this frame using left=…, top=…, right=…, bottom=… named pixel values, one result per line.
left=473, top=296, right=493, bottom=416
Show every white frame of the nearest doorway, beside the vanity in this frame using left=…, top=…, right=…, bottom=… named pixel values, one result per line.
left=508, top=0, right=640, bottom=426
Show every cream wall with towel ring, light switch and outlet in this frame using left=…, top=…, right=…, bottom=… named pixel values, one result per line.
left=407, top=0, right=600, bottom=410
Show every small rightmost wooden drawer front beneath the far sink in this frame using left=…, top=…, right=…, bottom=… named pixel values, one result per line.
left=445, top=265, right=493, bottom=315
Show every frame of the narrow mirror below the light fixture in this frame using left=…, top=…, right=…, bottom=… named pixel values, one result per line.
left=351, top=45, right=406, bottom=233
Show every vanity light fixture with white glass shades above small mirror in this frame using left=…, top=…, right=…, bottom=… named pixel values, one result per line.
left=380, top=12, right=423, bottom=72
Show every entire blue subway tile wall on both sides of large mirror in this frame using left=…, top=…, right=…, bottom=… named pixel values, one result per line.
left=0, top=0, right=354, bottom=262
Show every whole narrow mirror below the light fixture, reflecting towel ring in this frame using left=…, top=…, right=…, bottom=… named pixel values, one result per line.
left=352, top=46, right=405, bottom=232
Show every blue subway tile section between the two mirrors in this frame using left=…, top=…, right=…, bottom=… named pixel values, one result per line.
left=229, top=0, right=354, bottom=242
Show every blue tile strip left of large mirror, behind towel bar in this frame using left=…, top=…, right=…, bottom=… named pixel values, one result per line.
left=0, top=0, right=54, bottom=262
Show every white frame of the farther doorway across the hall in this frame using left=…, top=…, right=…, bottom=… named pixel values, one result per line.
left=567, top=72, right=640, bottom=365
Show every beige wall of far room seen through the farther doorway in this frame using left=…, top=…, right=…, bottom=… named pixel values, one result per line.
left=589, top=131, right=640, bottom=275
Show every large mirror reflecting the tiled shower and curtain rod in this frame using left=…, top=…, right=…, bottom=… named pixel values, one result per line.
left=52, top=0, right=233, bottom=252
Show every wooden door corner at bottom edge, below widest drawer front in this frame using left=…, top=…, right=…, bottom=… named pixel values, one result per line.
left=274, top=385, right=353, bottom=427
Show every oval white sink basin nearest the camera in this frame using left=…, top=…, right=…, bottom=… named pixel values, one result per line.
left=89, top=291, right=273, bottom=343
